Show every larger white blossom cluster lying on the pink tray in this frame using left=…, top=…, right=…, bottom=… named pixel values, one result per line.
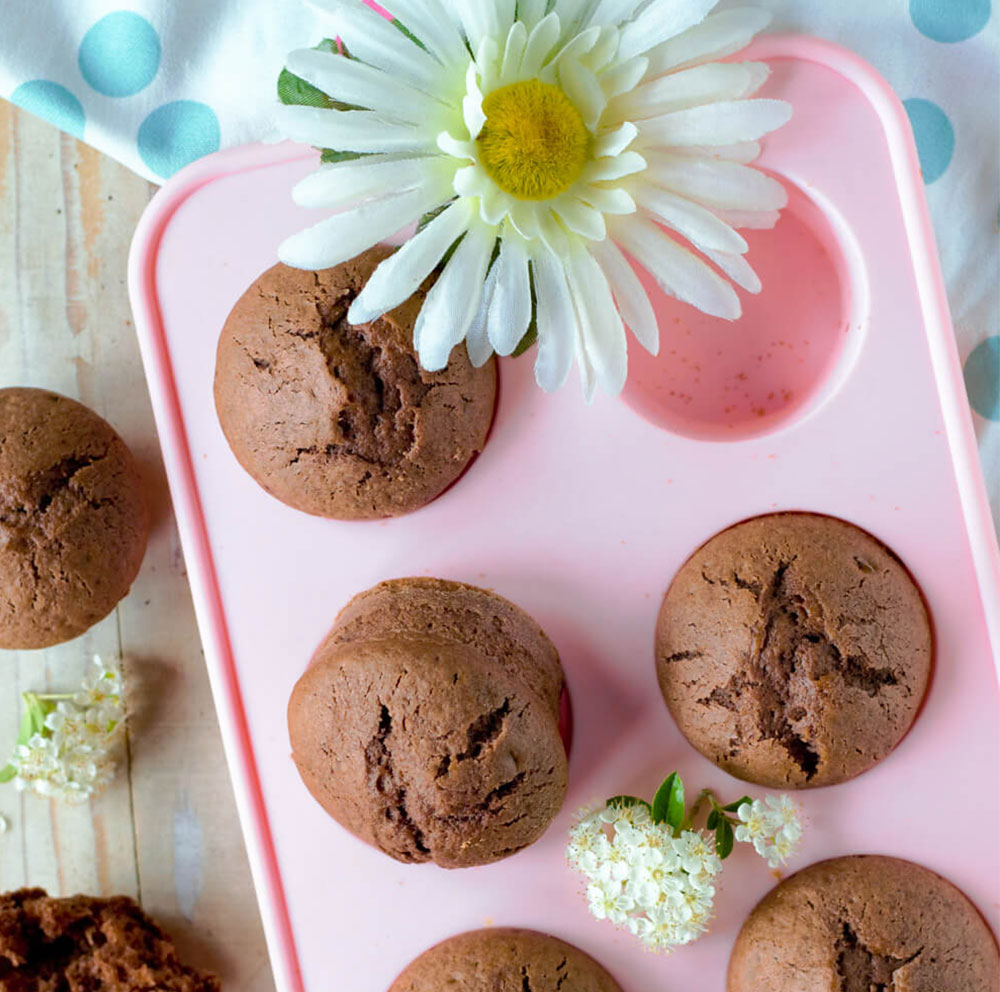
left=567, top=805, right=722, bottom=951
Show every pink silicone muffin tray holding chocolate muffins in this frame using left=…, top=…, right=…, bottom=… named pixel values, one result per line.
left=130, top=38, right=1000, bottom=992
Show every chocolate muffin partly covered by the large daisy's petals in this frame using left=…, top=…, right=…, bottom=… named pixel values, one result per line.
left=215, top=245, right=496, bottom=520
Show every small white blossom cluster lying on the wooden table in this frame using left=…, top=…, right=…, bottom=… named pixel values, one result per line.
left=10, top=656, right=125, bottom=803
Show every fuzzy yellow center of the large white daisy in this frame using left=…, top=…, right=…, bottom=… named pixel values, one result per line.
left=477, top=79, right=590, bottom=200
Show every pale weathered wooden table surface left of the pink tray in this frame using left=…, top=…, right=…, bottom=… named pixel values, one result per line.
left=0, top=101, right=274, bottom=992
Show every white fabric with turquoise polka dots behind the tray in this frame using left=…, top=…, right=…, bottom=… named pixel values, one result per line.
left=0, top=0, right=1000, bottom=519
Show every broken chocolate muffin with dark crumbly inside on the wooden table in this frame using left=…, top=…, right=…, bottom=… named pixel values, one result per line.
left=0, top=889, right=221, bottom=992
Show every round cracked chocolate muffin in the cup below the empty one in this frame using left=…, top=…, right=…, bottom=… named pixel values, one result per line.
left=656, top=513, right=933, bottom=788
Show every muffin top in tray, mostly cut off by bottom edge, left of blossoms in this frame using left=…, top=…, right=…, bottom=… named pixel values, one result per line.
left=389, top=927, right=620, bottom=992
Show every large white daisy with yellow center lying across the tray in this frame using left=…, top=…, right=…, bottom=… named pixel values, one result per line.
left=280, top=0, right=791, bottom=399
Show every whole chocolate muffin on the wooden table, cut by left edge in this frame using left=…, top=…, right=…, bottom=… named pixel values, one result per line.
left=0, top=389, right=149, bottom=649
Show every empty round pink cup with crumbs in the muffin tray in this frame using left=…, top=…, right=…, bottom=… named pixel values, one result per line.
left=622, top=176, right=869, bottom=441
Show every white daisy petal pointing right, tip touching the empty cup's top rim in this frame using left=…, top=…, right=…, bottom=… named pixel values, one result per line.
left=647, top=152, right=788, bottom=211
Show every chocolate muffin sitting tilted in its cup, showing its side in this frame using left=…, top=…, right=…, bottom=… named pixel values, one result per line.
left=288, top=579, right=567, bottom=868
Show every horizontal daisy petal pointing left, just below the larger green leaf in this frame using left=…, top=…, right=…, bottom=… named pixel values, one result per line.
left=276, top=105, right=435, bottom=153
